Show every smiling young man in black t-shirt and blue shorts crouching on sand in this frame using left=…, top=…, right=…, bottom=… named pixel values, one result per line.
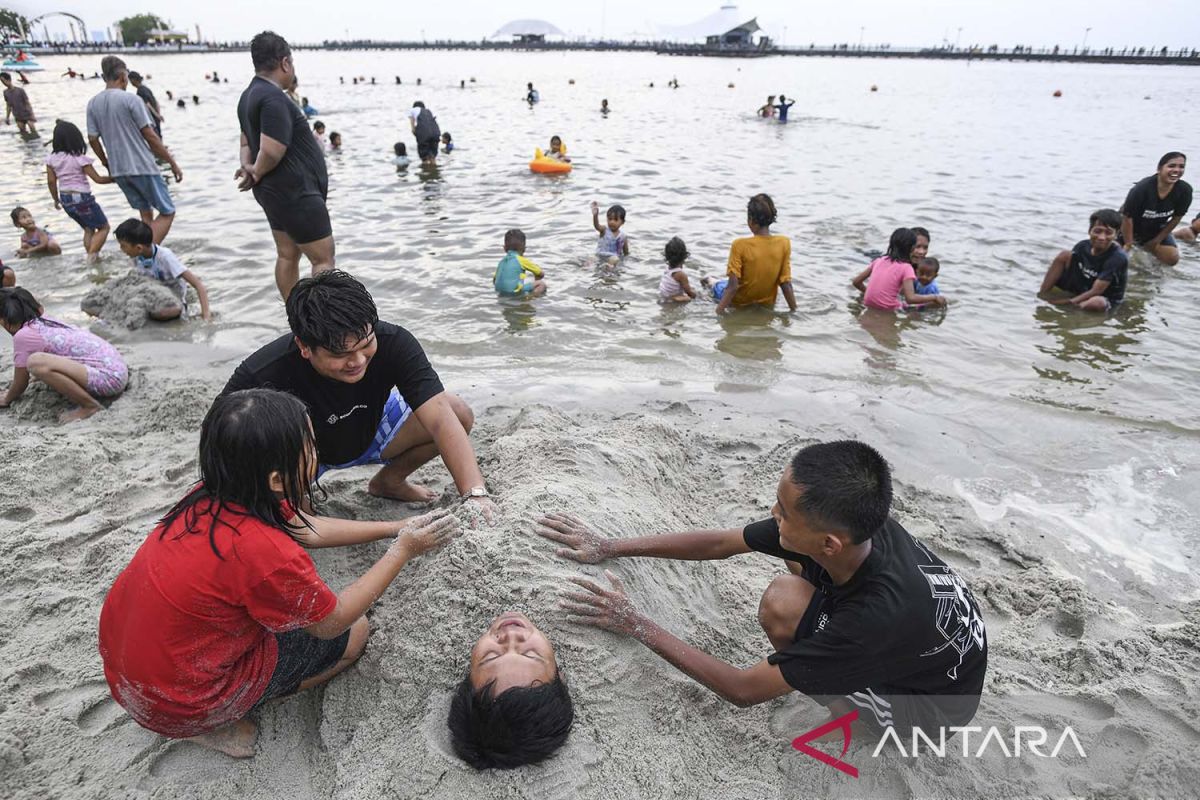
left=221, top=268, right=496, bottom=519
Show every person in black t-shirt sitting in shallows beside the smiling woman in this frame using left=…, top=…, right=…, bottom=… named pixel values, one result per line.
left=1038, top=209, right=1129, bottom=312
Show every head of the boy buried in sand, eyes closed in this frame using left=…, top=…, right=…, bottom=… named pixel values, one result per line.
left=446, top=612, right=575, bottom=769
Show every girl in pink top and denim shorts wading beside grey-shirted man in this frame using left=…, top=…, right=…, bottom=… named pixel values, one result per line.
left=46, top=120, right=113, bottom=260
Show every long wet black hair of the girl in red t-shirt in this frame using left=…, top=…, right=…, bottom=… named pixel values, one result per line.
left=158, top=389, right=317, bottom=559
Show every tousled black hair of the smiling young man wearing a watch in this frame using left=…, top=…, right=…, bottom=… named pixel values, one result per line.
left=284, top=270, right=379, bottom=353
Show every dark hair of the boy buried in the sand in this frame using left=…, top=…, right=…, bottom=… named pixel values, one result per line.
left=446, top=674, right=575, bottom=770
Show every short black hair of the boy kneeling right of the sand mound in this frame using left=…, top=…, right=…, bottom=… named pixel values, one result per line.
left=791, top=441, right=892, bottom=545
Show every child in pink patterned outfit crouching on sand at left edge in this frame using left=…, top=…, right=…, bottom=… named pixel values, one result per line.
left=0, top=287, right=130, bottom=422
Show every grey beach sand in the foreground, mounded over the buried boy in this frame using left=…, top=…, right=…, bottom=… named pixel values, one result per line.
left=0, top=383, right=1200, bottom=800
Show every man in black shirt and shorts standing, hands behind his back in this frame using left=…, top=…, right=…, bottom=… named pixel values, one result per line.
left=236, top=31, right=334, bottom=300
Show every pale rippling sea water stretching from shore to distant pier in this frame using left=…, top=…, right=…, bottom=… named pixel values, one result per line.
left=0, top=52, right=1200, bottom=603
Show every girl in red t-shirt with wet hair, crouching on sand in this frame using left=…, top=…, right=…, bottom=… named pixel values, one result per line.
left=100, top=389, right=458, bottom=758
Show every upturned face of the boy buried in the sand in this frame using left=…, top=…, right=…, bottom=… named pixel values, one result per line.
left=469, top=612, right=558, bottom=694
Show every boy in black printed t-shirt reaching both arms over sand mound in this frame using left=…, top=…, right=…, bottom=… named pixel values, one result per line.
left=535, top=441, right=988, bottom=740
